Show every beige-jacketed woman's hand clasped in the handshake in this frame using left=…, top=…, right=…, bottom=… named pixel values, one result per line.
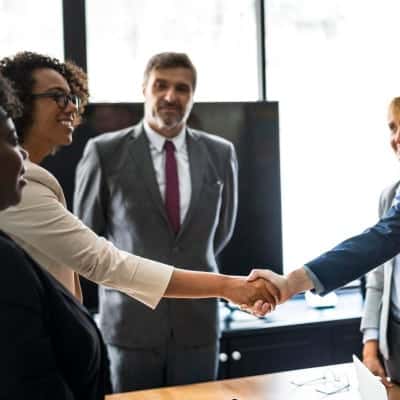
left=223, top=276, right=279, bottom=316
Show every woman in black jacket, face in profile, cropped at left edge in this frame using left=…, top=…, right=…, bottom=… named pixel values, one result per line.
left=0, top=75, right=109, bottom=400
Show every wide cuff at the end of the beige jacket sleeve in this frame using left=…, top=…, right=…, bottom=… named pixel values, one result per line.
left=125, top=257, right=174, bottom=309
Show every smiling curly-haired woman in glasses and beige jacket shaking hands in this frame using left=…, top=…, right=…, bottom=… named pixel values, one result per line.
left=0, top=52, right=275, bottom=332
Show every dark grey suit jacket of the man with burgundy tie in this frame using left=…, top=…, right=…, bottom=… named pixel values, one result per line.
left=74, top=124, right=237, bottom=348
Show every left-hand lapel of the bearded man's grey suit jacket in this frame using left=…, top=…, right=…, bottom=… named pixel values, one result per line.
left=128, top=124, right=169, bottom=224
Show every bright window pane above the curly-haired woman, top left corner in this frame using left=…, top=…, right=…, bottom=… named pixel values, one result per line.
left=0, top=0, right=64, bottom=59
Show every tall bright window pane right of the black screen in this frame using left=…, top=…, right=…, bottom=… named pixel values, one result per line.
left=266, top=0, right=400, bottom=272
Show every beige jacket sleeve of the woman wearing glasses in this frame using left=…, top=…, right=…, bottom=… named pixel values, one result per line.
left=0, top=181, right=173, bottom=308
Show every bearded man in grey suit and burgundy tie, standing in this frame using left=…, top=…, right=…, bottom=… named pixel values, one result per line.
left=74, top=53, right=237, bottom=392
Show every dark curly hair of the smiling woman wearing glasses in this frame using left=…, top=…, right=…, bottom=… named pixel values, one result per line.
left=0, top=51, right=89, bottom=143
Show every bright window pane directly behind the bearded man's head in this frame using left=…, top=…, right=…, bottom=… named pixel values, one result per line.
left=86, top=0, right=258, bottom=102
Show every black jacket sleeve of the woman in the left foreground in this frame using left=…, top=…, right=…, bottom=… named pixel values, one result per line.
left=0, top=238, right=74, bottom=400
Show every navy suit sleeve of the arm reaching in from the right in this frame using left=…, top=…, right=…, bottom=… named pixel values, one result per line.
left=306, top=205, right=400, bottom=294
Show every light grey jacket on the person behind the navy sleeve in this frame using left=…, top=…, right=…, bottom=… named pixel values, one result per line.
left=361, top=182, right=400, bottom=359
